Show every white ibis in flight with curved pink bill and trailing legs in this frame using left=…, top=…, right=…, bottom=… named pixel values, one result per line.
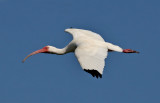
left=23, top=28, right=139, bottom=78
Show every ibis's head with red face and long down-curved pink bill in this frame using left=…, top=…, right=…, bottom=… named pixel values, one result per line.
left=22, top=46, right=54, bottom=63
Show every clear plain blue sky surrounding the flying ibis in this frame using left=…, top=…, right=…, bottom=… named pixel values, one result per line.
left=0, top=0, right=160, bottom=103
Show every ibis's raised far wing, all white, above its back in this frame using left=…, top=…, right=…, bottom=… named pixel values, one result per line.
left=65, top=28, right=104, bottom=41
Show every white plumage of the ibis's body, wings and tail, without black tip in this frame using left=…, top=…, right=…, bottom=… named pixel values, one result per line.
left=65, top=28, right=122, bottom=74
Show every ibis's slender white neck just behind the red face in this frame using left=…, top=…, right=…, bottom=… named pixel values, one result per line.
left=48, top=47, right=66, bottom=55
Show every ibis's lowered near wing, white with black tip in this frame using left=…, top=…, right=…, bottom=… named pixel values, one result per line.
left=75, top=45, right=108, bottom=78
